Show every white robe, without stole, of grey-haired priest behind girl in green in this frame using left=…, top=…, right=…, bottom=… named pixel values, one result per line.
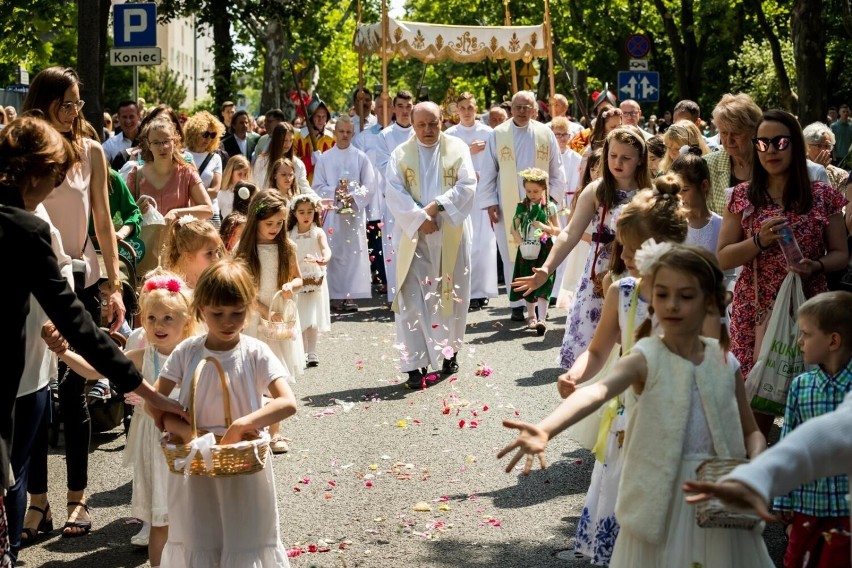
left=477, top=122, right=565, bottom=308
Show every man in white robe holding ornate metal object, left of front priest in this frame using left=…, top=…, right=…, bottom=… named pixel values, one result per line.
left=313, top=116, right=376, bottom=311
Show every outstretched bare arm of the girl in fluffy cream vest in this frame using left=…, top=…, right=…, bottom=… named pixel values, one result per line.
left=497, top=353, right=648, bottom=475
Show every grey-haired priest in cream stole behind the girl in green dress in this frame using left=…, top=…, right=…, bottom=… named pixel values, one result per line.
left=478, top=91, right=565, bottom=321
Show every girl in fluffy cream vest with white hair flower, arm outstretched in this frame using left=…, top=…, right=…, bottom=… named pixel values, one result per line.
left=497, top=241, right=774, bottom=568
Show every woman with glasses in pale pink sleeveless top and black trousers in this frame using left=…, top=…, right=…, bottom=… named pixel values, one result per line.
left=22, top=67, right=130, bottom=537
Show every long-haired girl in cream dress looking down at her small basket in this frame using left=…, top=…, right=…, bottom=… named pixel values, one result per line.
left=235, top=189, right=305, bottom=454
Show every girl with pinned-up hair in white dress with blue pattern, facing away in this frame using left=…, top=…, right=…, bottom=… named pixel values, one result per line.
left=557, top=183, right=692, bottom=566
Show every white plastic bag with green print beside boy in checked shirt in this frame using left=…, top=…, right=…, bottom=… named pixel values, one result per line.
left=745, top=272, right=810, bottom=416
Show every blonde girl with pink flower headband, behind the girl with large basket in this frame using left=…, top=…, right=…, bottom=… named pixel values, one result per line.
left=60, top=270, right=195, bottom=567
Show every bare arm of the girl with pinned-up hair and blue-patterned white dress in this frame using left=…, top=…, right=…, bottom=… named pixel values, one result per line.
left=556, top=283, right=621, bottom=398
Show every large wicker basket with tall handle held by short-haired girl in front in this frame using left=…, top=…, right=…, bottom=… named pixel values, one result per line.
left=160, top=357, right=269, bottom=477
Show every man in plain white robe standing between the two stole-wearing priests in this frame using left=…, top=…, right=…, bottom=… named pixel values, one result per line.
left=446, top=93, right=497, bottom=309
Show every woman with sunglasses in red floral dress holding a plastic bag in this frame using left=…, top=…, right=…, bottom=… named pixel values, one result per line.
left=718, top=110, right=849, bottom=435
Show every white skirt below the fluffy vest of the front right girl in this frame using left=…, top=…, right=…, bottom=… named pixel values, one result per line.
left=610, top=456, right=775, bottom=568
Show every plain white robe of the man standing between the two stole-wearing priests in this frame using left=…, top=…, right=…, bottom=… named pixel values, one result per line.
left=446, top=121, right=497, bottom=298
